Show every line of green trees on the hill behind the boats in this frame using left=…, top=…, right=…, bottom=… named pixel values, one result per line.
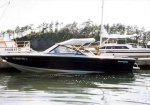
left=0, top=19, right=150, bottom=43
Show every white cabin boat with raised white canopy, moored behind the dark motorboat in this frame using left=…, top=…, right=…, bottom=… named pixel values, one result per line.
left=96, top=27, right=150, bottom=58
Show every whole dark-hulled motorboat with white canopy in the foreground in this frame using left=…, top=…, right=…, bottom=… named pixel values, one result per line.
left=0, top=38, right=135, bottom=74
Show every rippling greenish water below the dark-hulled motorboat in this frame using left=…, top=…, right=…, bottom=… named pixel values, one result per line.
left=0, top=70, right=150, bottom=105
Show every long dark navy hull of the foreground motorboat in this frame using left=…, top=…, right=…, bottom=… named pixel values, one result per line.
left=2, top=55, right=135, bottom=74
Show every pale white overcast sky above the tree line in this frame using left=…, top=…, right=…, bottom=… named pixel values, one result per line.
left=0, top=0, right=150, bottom=31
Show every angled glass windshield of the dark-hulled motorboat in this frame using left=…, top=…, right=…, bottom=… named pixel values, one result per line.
left=49, top=45, right=84, bottom=55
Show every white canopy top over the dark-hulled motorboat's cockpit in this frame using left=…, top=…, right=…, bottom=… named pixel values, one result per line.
left=57, top=38, right=95, bottom=45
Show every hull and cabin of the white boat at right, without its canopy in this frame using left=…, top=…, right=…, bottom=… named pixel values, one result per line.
left=99, top=43, right=150, bottom=58
